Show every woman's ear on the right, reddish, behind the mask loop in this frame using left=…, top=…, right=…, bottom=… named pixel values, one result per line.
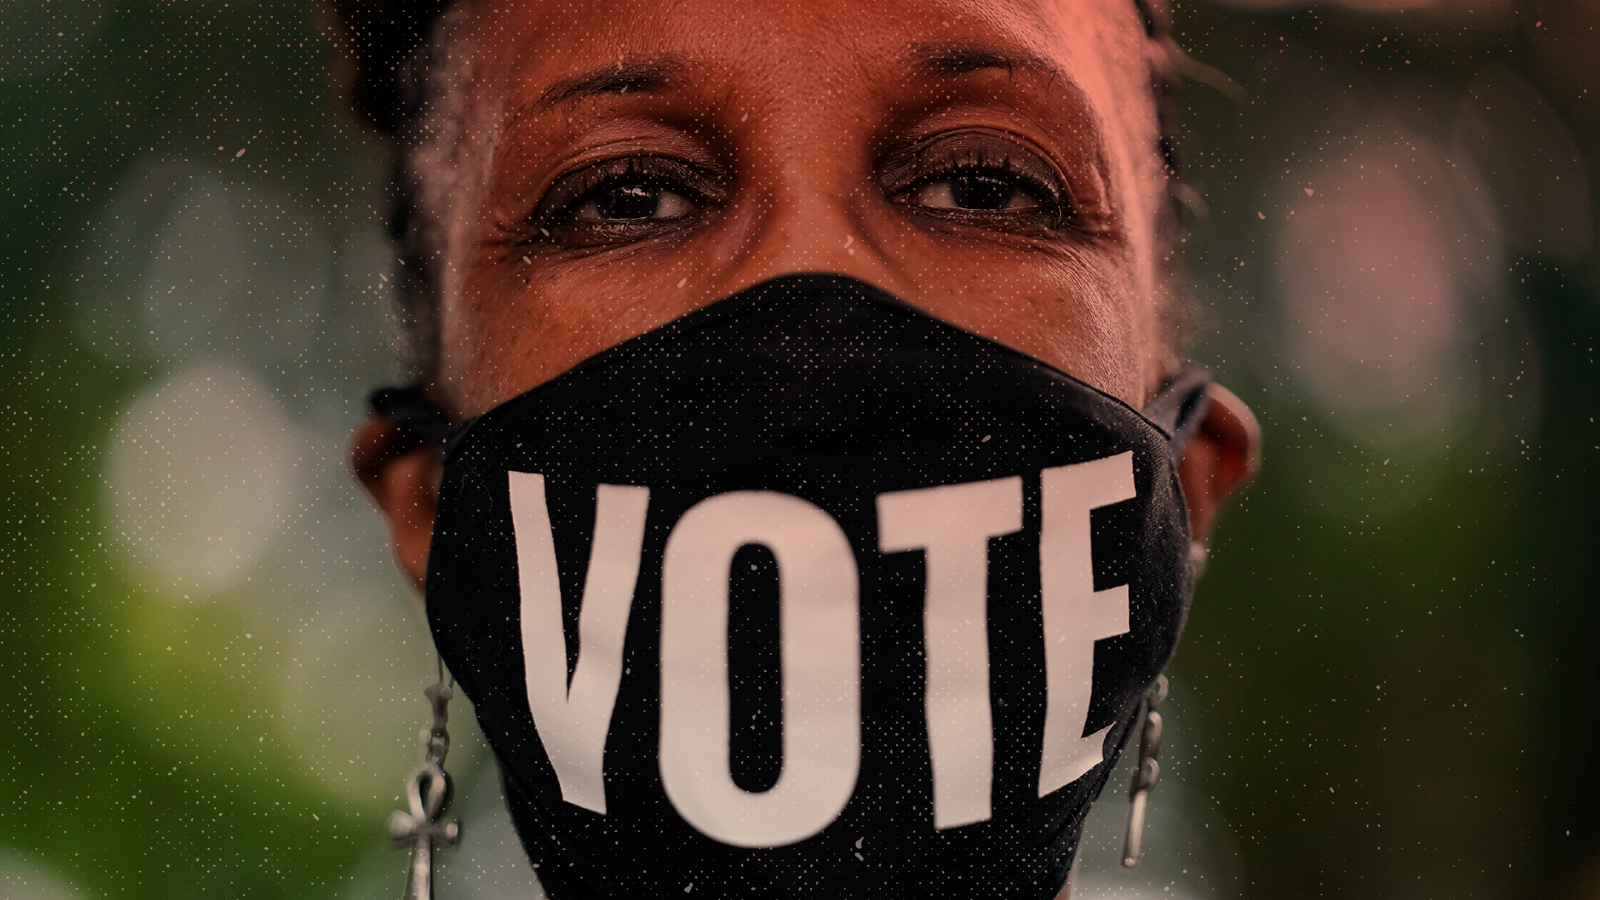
left=1178, top=384, right=1261, bottom=544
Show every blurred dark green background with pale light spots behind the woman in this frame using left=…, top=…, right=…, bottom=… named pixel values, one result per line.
left=0, top=0, right=1600, bottom=900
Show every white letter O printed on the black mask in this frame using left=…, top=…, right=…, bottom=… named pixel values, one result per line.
left=659, top=490, right=861, bottom=847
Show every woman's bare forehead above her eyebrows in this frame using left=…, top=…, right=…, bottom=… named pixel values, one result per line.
left=466, top=0, right=1149, bottom=119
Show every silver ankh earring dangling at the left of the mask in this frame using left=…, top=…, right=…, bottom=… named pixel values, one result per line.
left=389, top=661, right=461, bottom=900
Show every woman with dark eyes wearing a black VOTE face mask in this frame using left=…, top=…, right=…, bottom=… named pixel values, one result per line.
left=342, top=0, right=1254, bottom=900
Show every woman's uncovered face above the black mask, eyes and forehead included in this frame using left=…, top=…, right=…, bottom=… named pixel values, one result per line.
left=440, top=0, right=1168, bottom=415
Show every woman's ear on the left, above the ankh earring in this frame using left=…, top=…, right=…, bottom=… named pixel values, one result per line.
left=350, top=415, right=442, bottom=593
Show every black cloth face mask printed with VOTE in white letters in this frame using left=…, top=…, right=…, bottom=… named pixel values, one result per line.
left=374, top=275, right=1206, bottom=900
